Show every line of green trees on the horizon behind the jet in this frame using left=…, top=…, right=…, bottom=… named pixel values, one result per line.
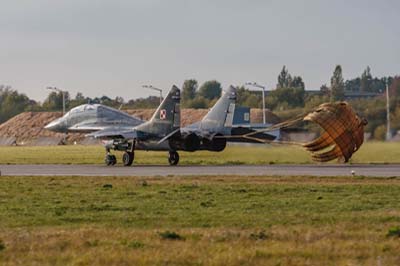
left=0, top=65, right=400, bottom=138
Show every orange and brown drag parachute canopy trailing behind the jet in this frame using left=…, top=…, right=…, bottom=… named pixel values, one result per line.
left=303, top=102, right=367, bottom=162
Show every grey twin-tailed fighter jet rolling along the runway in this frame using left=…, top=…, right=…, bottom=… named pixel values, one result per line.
left=46, top=86, right=276, bottom=166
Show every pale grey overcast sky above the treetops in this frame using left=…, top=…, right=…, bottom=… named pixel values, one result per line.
left=0, top=0, right=400, bottom=101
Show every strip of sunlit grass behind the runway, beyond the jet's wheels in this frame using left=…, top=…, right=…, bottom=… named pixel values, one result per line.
left=0, top=142, right=400, bottom=165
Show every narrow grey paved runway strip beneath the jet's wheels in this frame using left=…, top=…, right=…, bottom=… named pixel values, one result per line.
left=0, top=164, right=400, bottom=177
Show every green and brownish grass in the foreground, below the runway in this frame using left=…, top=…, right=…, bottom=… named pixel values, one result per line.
left=0, top=176, right=400, bottom=265
